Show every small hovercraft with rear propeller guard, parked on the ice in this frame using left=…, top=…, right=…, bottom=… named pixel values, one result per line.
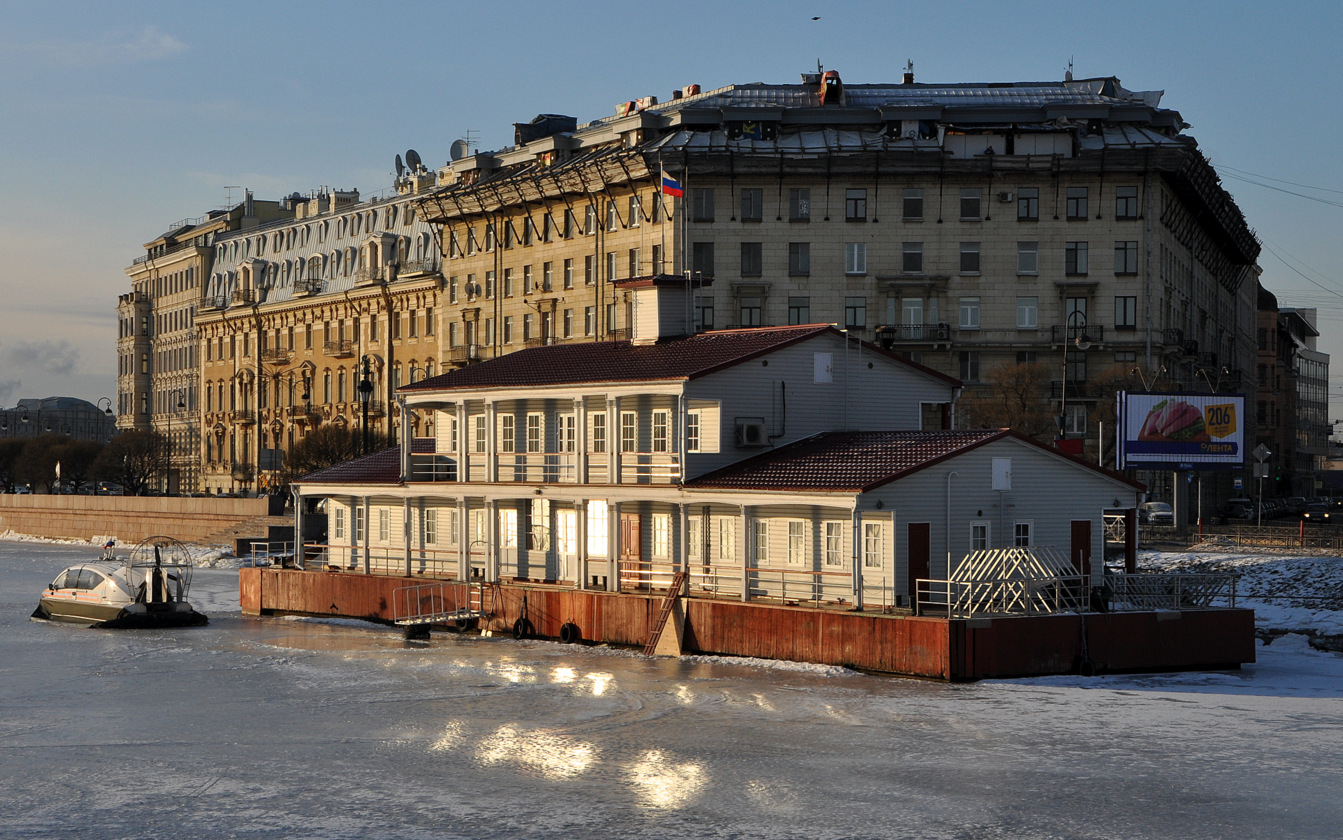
left=32, top=536, right=210, bottom=628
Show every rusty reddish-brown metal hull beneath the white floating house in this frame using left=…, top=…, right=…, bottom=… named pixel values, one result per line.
left=239, top=569, right=1254, bottom=680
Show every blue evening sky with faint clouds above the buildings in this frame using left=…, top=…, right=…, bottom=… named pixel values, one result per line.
left=0, top=0, right=1343, bottom=419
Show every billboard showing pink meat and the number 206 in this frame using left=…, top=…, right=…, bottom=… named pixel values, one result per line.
left=1117, top=391, right=1245, bottom=469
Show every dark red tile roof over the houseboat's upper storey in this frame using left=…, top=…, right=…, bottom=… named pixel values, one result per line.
left=400, top=324, right=960, bottom=392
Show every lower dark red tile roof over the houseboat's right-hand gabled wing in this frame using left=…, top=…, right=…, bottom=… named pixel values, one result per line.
left=686, top=429, right=1143, bottom=492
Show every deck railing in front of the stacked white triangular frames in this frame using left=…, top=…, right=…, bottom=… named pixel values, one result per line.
left=915, top=575, right=1091, bottom=618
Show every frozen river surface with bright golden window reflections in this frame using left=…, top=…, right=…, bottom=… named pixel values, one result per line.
left=0, top=542, right=1343, bottom=840
